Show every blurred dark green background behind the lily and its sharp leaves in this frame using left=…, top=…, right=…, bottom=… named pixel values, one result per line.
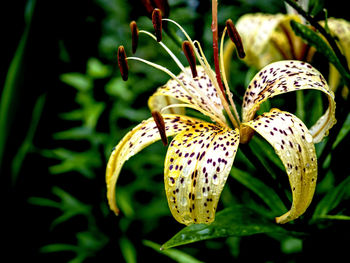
left=0, top=0, right=349, bottom=262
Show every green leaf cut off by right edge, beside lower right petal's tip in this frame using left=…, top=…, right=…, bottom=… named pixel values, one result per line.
left=312, top=176, right=350, bottom=220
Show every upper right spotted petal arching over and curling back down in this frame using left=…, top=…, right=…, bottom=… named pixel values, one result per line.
left=242, top=60, right=336, bottom=143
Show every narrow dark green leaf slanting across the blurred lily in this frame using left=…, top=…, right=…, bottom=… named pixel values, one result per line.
left=290, top=20, right=350, bottom=82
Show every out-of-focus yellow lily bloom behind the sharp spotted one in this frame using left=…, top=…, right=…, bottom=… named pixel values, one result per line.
left=225, top=13, right=350, bottom=95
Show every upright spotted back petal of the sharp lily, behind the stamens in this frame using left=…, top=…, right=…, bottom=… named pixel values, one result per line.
left=148, top=66, right=225, bottom=120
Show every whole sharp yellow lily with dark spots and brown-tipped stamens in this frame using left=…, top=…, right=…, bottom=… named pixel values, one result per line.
left=106, top=6, right=335, bottom=225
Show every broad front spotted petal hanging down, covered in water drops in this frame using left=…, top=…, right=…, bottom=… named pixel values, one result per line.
left=164, top=122, right=239, bottom=225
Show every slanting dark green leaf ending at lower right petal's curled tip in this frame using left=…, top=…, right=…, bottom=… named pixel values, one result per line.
left=231, top=167, right=287, bottom=215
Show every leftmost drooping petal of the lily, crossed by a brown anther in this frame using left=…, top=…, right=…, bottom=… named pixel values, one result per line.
left=106, top=114, right=205, bottom=217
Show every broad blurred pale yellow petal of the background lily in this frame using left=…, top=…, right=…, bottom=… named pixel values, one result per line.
left=225, top=13, right=301, bottom=69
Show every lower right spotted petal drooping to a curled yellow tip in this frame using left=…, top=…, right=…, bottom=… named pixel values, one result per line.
left=244, top=109, right=317, bottom=224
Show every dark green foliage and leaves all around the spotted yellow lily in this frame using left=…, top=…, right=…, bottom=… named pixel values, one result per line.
left=0, top=0, right=350, bottom=263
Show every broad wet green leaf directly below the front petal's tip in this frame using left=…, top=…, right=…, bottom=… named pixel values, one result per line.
left=162, top=205, right=286, bottom=249
